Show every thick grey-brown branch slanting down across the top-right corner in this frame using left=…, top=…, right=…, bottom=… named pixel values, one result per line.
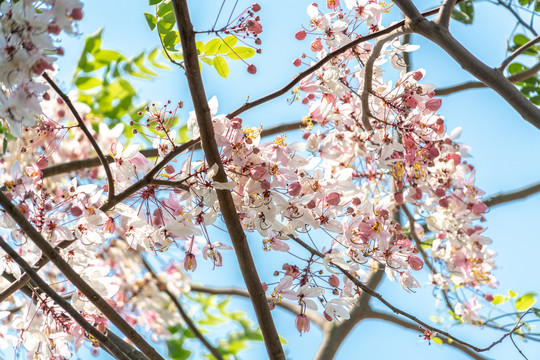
left=395, top=0, right=540, bottom=129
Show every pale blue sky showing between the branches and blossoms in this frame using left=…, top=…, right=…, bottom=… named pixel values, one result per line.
left=43, top=0, right=540, bottom=359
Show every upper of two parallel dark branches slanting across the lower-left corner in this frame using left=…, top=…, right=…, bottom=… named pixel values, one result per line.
left=0, top=192, right=164, bottom=360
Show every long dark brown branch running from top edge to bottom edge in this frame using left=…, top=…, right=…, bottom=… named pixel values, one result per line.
left=172, top=0, right=285, bottom=360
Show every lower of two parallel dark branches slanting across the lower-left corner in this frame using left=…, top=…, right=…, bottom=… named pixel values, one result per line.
left=0, top=236, right=136, bottom=360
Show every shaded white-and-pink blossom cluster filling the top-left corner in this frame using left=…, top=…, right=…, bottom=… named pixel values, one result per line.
left=0, top=0, right=83, bottom=137
